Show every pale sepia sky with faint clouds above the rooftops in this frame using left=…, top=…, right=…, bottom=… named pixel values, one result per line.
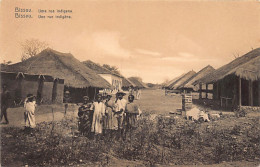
left=0, top=0, right=260, bottom=83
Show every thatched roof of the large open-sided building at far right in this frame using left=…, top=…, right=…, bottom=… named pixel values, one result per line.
left=199, top=48, right=260, bottom=83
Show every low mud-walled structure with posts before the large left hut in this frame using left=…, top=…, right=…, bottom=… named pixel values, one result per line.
left=1, top=71, right=64, bottom=105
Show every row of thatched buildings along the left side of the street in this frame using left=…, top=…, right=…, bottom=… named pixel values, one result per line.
left=1, top=48, right=145, bottom=104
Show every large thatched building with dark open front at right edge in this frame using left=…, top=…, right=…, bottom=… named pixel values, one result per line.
left=198, top=48, right=260, bottom=108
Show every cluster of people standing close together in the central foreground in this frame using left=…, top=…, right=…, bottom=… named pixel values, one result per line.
left=78, top=92, right=141, bottom=138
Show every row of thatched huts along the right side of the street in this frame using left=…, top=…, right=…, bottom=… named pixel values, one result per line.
left=164, top=48, right=260, bottom=108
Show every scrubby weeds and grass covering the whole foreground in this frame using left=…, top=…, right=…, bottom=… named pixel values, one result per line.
left=1, top=113, right=260, bottom=166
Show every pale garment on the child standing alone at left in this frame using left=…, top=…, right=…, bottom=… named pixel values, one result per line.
left=24, top=101, right=36, bottom=128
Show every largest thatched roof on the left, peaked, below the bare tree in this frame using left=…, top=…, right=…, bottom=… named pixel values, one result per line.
left=6, top=48, right=111, bottom=88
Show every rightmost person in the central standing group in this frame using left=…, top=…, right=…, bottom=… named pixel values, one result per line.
left=125, top=95, right=141, bottom=136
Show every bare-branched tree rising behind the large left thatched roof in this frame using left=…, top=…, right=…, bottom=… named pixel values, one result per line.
left=21, top=39, right=48, bottom=61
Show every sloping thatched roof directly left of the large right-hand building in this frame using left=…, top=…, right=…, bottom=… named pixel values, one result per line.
left=178, top=65, right=215, bottom=90
